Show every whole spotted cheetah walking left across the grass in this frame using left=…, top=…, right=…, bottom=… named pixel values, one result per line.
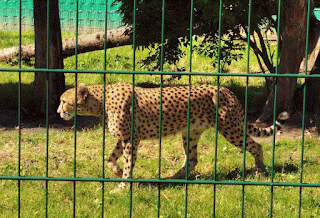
left=57, top=83, right=281, bottom=188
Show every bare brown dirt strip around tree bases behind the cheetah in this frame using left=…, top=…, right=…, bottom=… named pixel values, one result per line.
left=0, top=110, right=320, bottom=139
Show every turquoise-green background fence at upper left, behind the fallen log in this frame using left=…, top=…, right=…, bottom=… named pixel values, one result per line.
left=0, top=0, right=122, bottom=31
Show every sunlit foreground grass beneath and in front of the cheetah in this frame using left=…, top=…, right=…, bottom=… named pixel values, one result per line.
left=0, top=125, right=320, bottom=217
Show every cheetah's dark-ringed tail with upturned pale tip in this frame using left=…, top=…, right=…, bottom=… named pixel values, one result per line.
left=248, top=112, right=290, bottom=137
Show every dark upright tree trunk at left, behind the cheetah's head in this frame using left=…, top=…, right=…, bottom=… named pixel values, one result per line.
left=33, top=0, right=65, bottom=117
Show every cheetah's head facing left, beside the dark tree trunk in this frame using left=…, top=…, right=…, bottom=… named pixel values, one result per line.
left=57, top=83, right=89, bottom=120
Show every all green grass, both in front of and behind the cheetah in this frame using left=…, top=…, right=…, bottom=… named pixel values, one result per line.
left=0, top=32, right=320, bottom=217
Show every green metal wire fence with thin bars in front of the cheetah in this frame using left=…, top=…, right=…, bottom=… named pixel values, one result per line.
left=0, top=0, right=320, bottom=217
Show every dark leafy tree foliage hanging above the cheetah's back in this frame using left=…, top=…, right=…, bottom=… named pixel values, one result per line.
left=116, top=0, right=278, bottom=70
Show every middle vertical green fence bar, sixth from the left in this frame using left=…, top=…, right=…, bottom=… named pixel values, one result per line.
left=157, top=0, right=165, bottom=217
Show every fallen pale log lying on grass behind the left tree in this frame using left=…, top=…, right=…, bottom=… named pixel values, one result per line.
left=0, top=27, right=132, bottom=61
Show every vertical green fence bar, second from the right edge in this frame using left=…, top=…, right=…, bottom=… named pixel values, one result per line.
left=270, top=0, right=282, bottom=218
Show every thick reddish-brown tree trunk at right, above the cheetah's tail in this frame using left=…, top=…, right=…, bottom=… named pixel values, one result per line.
left=257, top=0, right=319, bottom=122
